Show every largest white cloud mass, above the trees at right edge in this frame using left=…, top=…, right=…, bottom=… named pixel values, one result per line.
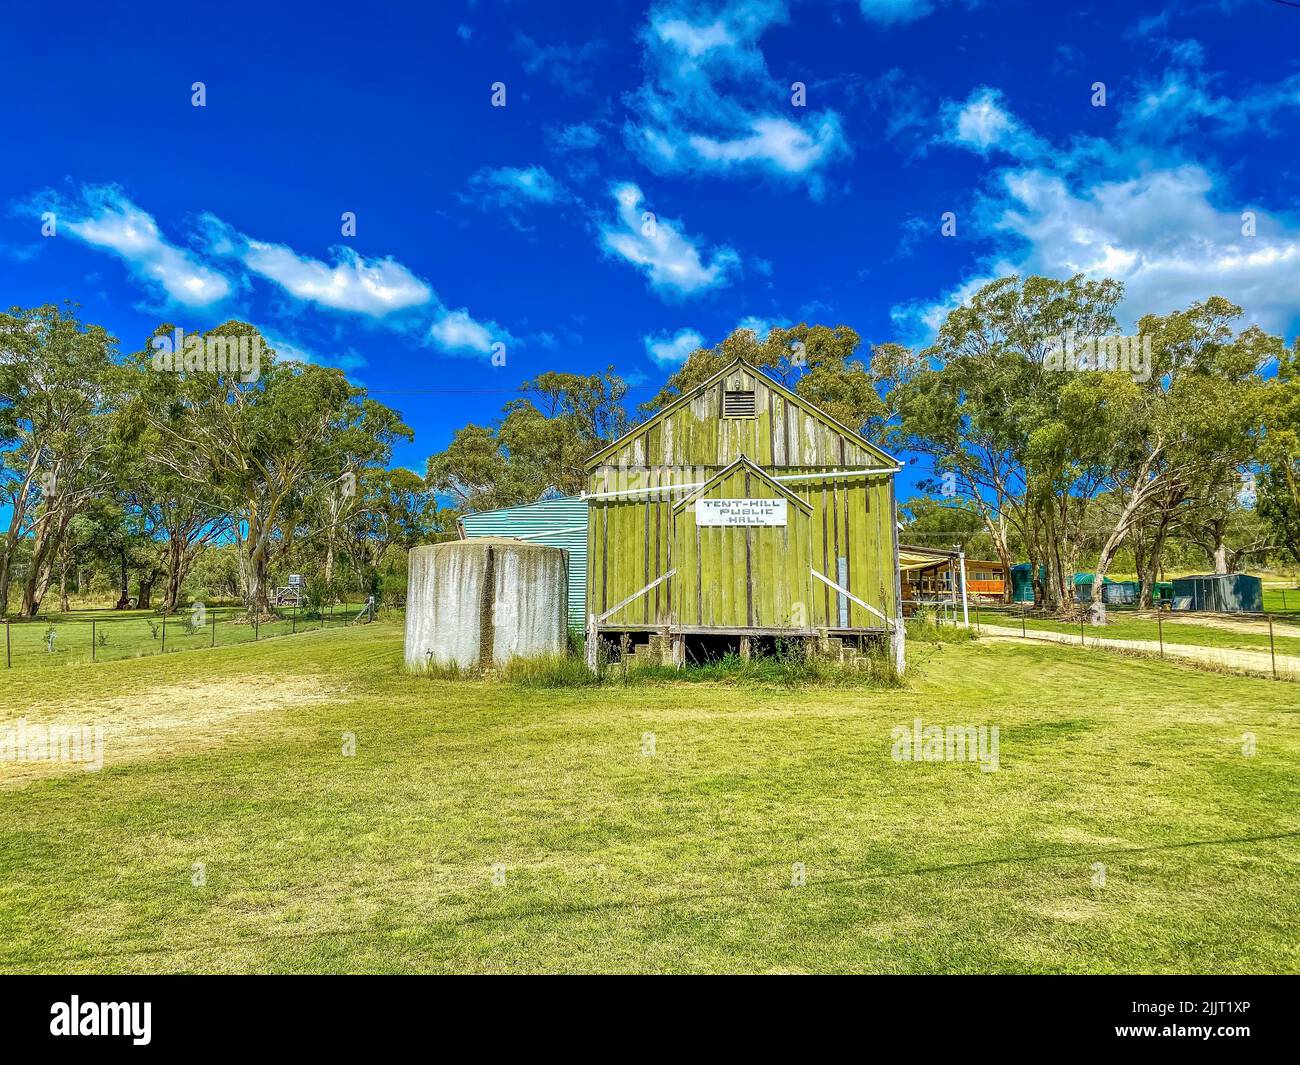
left=893, top=65, right=1300, bottom=342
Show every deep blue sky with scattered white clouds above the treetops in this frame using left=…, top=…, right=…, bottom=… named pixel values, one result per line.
left=0, top=0, right=1300, bottom=495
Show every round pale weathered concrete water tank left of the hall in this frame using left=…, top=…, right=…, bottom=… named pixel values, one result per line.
left=406, top=537, right=568, bottom=670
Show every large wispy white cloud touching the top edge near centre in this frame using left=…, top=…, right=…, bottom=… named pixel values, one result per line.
left=623, top=0, right=849, bottom=196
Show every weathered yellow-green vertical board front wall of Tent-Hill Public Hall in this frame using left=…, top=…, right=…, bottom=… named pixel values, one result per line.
left=588, top=359, right=897, bottom=632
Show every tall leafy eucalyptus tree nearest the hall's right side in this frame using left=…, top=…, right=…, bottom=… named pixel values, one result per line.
left=897, top=276, right=1123, bottom=609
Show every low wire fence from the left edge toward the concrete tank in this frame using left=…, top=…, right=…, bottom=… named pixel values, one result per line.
left=4, top=601, right=378, bottom=670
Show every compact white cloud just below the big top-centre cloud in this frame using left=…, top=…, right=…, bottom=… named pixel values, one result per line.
left=599, top=182, right=740, bottom=295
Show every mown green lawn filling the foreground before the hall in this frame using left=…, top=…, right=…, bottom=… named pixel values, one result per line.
left=0, top=623, right=1300, bottom=973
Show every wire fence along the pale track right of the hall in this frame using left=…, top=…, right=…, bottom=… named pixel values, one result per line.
left=913, top=590, right=1300, bottom=681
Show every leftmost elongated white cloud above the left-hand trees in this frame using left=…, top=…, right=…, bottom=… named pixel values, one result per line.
left=42, top=185, right=233, bottom=308
